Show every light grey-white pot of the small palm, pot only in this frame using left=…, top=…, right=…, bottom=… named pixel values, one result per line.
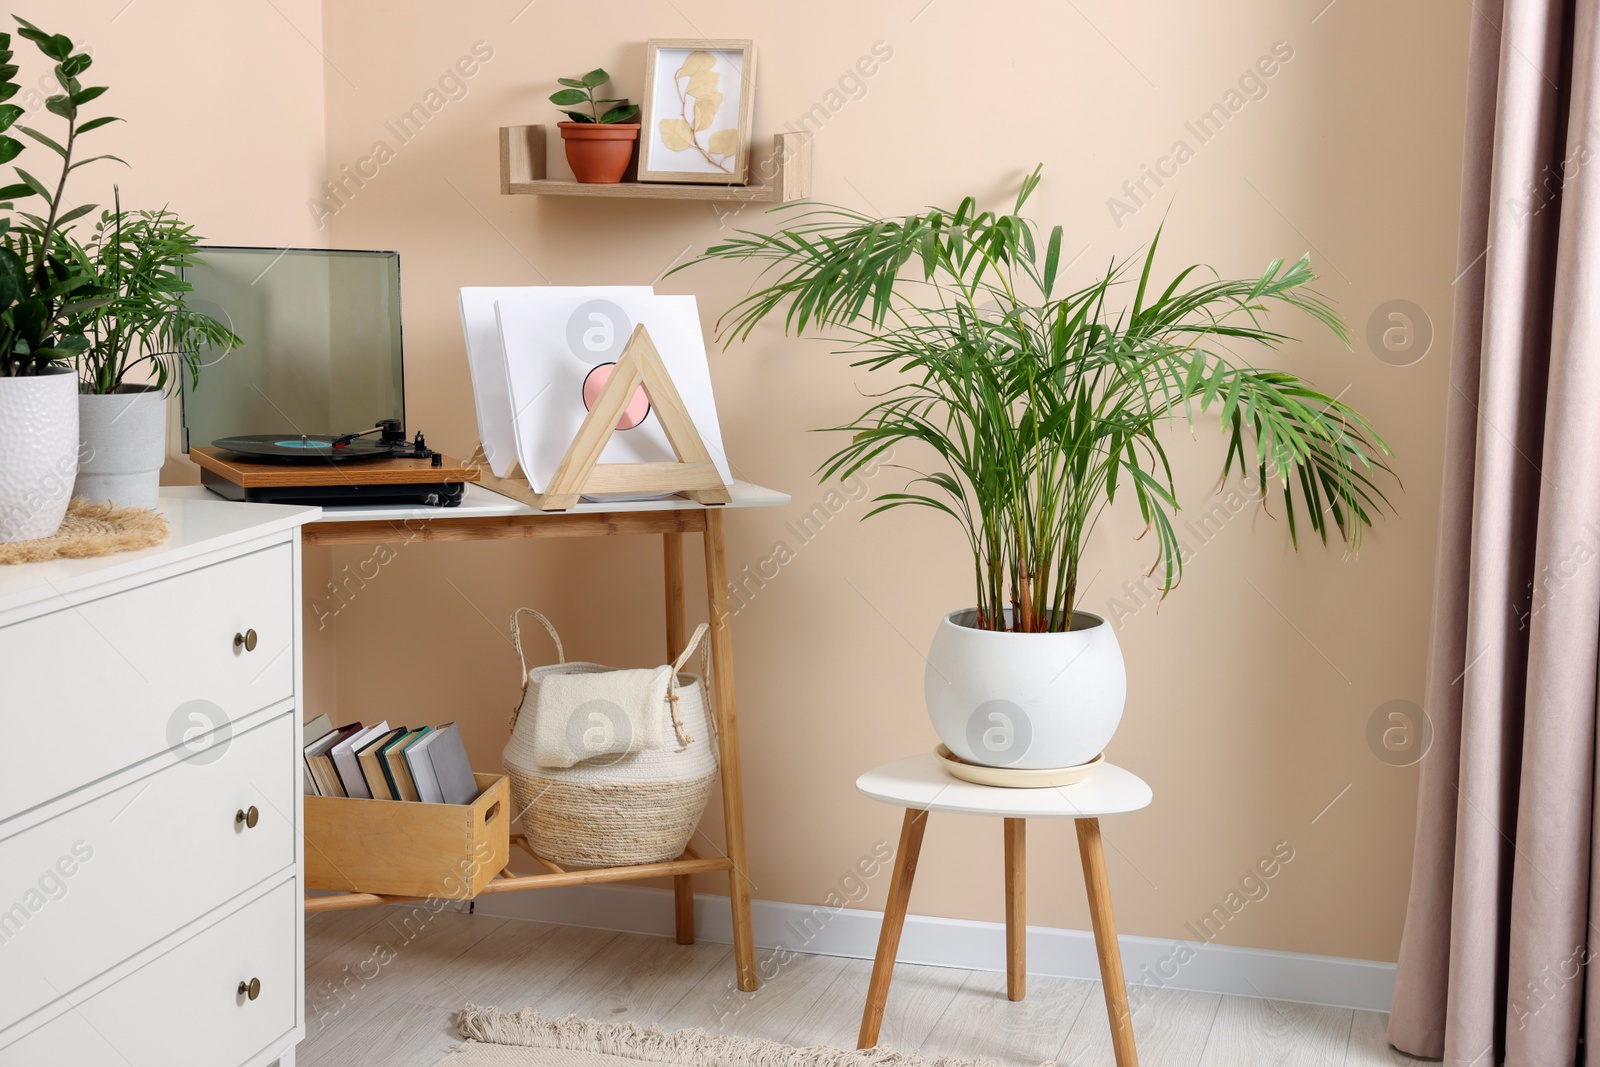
left=72, top=387, right=166, bottom=507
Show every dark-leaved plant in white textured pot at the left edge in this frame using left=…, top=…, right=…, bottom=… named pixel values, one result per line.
left=0, top=18, right=117, bottom=542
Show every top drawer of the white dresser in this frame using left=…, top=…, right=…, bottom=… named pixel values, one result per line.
left=0, top=544, right=296, bottom=817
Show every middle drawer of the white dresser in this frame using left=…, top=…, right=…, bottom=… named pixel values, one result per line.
left=0, top=713, right=299, bottom=1030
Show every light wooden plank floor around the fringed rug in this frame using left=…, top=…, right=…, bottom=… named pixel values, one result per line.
left=298, top=907, right=1424, bottom=1067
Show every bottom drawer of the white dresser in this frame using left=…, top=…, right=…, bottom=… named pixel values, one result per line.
left=0, top=881, right=301, bottom=1067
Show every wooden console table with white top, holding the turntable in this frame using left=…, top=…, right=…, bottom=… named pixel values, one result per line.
left=165, top=482, right=789, bottom=990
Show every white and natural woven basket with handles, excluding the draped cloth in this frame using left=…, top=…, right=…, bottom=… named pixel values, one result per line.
left=504, top=608, right=717, bottom=867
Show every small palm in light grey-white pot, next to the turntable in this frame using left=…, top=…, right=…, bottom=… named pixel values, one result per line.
left=64, top=206, right=238, bottom=507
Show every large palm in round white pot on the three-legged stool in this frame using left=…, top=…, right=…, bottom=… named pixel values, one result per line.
left=696, top=170, right=1389, bottom=769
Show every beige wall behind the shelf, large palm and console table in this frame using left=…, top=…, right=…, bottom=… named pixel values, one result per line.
left=62, top=0, right=1470, bottom=960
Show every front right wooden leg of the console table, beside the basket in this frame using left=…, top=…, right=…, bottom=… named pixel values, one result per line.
left=706, top=509, right=758, bottom=992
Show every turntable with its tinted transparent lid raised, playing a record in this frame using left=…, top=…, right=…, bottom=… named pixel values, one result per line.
left=181, top=246, right=478, bottom=507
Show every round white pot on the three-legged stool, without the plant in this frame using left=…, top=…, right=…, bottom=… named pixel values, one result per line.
left=923, top=609, right=1128, bottom=769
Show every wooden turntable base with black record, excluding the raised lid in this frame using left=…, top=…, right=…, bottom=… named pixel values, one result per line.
left=189, top=419, right=478, bottom=507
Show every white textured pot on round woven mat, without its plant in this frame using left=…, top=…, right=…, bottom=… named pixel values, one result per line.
left=0, top=368, right=78, bottom=542
